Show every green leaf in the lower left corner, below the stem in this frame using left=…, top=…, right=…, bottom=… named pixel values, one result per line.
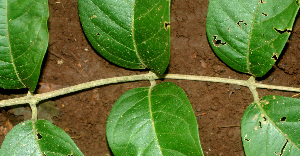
left=0, top=120, right=83, bottom=156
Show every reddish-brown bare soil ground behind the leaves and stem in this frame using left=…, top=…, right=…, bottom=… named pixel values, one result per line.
left=0, top=0, right=300, bottom=156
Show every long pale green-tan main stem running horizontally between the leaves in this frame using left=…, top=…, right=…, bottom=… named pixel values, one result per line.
left=0, top=72, right=300, bottom=107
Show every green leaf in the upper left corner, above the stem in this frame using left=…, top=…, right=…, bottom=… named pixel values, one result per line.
left=0, top=0, right=49, bottom=91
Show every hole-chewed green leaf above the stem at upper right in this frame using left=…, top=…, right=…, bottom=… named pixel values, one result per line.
left=206, top=0, right=299, bottom=77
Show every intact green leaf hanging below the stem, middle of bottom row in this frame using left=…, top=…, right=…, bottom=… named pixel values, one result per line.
left=106, top=82, right=203, bottom=156
